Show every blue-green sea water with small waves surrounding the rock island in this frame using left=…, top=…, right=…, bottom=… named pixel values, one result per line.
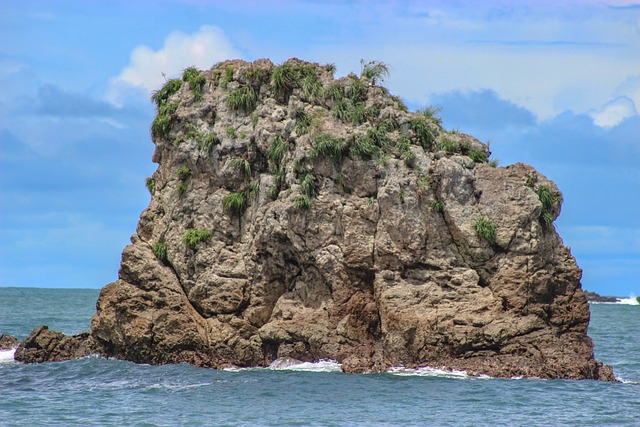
left=0, top=287, right=640, bottom=427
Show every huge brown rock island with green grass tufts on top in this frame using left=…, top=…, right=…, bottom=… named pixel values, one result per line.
left=16, top=59, right=613, bottom=380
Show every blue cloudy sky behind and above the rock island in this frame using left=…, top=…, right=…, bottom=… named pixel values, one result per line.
left=0, top=0, right=640, bottom=295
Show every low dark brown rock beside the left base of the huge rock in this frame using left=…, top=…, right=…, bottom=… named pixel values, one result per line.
left=14, top=325, right=101, bottom=363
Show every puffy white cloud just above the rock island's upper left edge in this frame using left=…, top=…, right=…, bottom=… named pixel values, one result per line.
left=107, top=25, right=240, bottom=105
